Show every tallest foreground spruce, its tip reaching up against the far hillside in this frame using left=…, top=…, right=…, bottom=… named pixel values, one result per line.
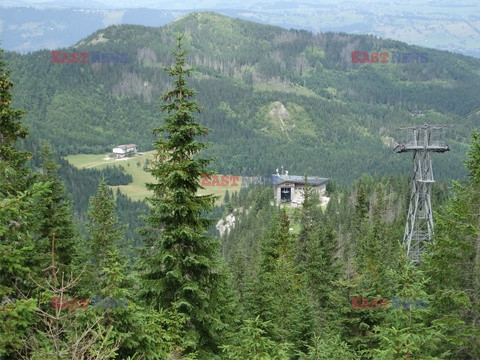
left=142, top=36, right=233, bottom=358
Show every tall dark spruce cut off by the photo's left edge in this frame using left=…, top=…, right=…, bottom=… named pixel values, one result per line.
left=0, top=49, right=48, bottom=357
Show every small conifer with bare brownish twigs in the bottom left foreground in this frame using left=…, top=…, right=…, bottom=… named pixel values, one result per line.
left=24, top=249, right=119, bottom=360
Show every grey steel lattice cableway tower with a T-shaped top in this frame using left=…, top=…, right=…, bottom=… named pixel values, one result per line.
left=395, top=125, right=450, bottom=264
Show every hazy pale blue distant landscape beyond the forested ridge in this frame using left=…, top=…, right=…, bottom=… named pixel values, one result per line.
left=0, top=0, right=480, bottom=57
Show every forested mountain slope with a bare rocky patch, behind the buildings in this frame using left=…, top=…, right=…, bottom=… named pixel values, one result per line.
left=6, top=13, right=480, bottom=183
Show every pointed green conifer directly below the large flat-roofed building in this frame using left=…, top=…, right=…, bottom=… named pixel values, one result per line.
left=249, top=209, right=315, bottom=358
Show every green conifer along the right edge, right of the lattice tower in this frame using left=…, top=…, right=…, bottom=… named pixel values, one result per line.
left=421, top=130, right=480, bottom=359
